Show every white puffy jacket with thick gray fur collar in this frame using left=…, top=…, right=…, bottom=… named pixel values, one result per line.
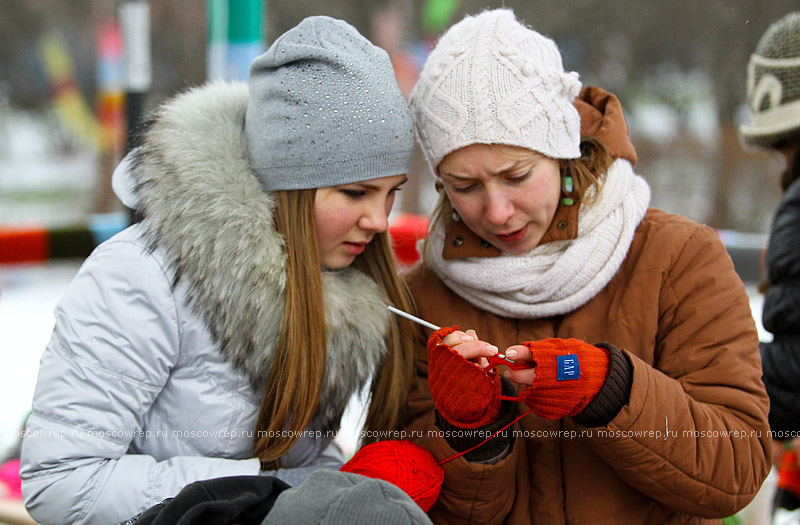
left=21, top=84, right=386, bottom=523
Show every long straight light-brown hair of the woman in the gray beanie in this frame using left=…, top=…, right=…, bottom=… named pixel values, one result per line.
left=253, top=189, right=417, bottom=470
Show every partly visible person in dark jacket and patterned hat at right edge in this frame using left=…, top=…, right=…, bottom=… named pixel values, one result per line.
left=740, top=11, right=800, bottom=520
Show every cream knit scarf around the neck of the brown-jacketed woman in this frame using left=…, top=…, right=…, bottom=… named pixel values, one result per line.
left=426, top=159, right=650, bottom=319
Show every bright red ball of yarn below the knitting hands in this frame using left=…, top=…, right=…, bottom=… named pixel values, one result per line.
left=339, top=441, right=444, bottom=512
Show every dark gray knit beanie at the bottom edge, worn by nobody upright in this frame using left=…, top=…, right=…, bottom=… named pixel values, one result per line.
left=261, top=469, right=431, bottom=525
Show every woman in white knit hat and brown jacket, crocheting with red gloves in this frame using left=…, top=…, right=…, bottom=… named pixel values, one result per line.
left=408, top=9, right=771, bottom=525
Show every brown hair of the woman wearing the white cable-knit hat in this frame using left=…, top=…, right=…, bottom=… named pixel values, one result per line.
left=423, top=137, right=614, bottom=257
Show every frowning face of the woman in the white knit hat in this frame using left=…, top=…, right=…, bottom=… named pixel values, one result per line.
left=438, top=144, right=561, bottom=255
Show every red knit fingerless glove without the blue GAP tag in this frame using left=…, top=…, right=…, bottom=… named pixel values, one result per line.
left=428, top=326, right=502, bottom=428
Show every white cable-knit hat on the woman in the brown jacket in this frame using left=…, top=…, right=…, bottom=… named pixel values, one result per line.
left=410, top=9, right=581, bottom=173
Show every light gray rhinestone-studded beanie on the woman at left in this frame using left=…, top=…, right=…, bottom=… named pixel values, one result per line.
left=245, top=16, right=414, bottom=191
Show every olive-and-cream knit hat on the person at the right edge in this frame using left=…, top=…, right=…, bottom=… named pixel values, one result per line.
left=739, top=11, right=800, bottom=147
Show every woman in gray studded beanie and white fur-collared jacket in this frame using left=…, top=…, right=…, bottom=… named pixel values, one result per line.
left=22, top=17, right=414, bottom=524
